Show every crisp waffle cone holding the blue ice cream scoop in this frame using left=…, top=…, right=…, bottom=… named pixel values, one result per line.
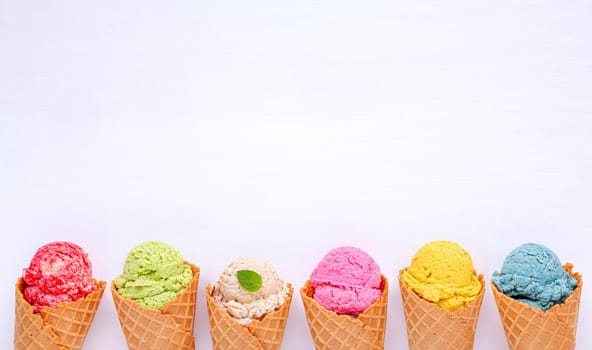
left=491, top=264, right=582, bottom=350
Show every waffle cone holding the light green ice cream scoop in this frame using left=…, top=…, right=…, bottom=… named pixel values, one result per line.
left=111, top=262, right=199, bottom=350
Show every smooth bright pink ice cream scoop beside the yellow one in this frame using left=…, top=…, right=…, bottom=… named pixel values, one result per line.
left=310, top=247, right=382, bottom=316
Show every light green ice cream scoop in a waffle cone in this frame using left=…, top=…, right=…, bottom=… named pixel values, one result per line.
left=115, top=241, right=193, bottom=309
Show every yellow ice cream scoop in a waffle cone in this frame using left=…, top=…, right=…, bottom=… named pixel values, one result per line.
left=402, top=241, right=482, bottom=311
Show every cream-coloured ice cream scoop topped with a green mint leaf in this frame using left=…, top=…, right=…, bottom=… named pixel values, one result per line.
left=212, top=257, right=289, bottom=325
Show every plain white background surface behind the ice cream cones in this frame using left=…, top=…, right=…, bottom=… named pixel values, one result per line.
left=0, top=0, right=592, bottom=350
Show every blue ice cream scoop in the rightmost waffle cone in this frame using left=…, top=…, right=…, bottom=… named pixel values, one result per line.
left=493, top=243, right=578, bottom=311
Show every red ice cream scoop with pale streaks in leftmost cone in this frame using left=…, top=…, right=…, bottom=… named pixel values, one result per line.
left=23, top=242, right=97, bottom=312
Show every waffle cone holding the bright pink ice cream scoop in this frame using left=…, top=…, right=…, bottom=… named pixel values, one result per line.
left=300, top=276, right=388, bottom=350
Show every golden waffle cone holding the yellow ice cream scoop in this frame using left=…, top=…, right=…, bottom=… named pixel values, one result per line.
left=399, top=270, right=485, bottom=350
